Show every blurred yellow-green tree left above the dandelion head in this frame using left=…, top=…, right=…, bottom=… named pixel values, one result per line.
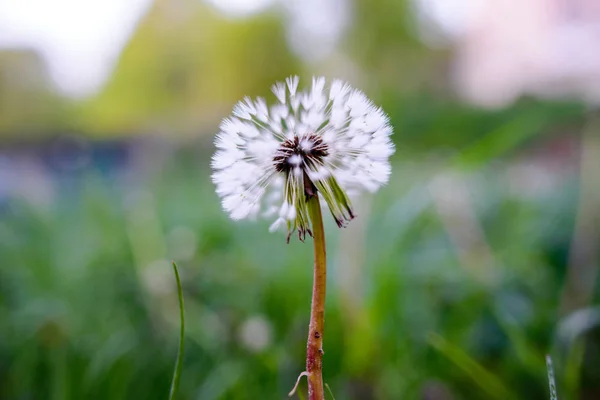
left=82, top=0, right=299, bottom=137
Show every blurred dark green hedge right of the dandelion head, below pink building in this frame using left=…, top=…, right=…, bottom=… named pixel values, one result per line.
left=382, top=92, right=586, bottom=153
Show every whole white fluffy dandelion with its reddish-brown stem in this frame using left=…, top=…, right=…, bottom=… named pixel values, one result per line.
left=211, top=76, right=394, bottom=399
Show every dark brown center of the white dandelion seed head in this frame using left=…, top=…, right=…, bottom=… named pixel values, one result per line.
left=273, top=133, right=329, bottom=172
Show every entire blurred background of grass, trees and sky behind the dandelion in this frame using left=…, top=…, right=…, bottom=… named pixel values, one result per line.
left=0, top=0, right=600, bottom=400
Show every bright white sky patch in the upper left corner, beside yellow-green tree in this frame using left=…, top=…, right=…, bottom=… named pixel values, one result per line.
left=0, top=0, right=151, bottom=96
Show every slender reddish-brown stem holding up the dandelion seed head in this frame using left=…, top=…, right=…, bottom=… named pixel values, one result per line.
left=306, top=193, right=327, bottom=400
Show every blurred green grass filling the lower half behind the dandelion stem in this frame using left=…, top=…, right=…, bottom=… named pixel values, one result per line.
left=0, top=142, right=600, bottom=400
